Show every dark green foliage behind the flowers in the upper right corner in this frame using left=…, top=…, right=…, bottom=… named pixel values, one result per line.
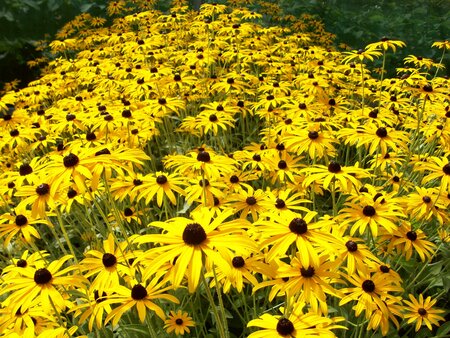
left=279, top=0, right=450, bottom=75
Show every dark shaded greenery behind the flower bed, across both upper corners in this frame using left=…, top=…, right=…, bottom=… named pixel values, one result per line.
left=0, top=0, right=450, bottom=88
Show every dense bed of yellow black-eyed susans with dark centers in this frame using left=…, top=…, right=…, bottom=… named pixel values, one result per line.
left=0, top=1, right=450, bottom=338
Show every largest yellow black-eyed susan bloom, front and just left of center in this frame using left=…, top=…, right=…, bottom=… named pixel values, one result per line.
left=136, top=208, right=256, bottom=292
